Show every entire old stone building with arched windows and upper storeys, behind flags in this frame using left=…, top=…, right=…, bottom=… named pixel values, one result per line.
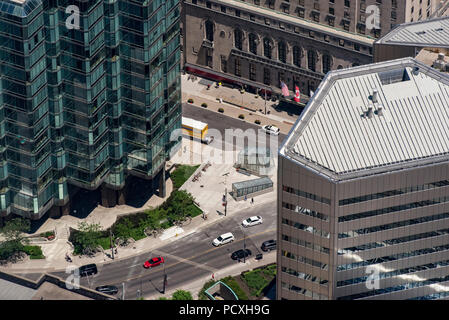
left=182, top=0, right=449, bottom=101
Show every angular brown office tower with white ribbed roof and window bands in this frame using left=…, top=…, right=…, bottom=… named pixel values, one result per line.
left=276, top=58, right=449, bottom=300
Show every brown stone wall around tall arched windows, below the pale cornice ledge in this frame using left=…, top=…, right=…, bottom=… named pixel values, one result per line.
left=183, top=0, right=372, bottom=95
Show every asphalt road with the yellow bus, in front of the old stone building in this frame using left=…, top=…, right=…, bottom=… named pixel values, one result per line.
left=182, top=103, right=287, bottom=153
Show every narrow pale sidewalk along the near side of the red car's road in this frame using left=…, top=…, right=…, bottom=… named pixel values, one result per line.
left=145, top=251, right=276, bottom=300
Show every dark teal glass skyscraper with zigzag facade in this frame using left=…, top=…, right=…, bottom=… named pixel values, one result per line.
left=0, top=0, right=181, bottom=219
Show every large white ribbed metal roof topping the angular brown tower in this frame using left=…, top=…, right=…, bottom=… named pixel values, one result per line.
left=280, top=58, right=449, bottom=179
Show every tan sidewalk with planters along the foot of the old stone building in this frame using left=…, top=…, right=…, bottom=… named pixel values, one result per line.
left=181, top=75, right=298, bottom=134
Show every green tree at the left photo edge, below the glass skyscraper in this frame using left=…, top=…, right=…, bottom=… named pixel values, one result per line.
left=0, top=218, right=30, bottom=260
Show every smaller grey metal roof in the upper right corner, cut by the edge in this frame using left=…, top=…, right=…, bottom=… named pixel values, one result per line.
left=375, top=17, right=449, bottom=48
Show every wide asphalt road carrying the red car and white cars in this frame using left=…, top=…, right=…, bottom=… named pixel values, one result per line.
left=52, top=202, right=276, bottom=300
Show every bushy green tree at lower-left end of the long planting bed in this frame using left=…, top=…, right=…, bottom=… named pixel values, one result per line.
left=71, top=222, right=102, bottom=254
